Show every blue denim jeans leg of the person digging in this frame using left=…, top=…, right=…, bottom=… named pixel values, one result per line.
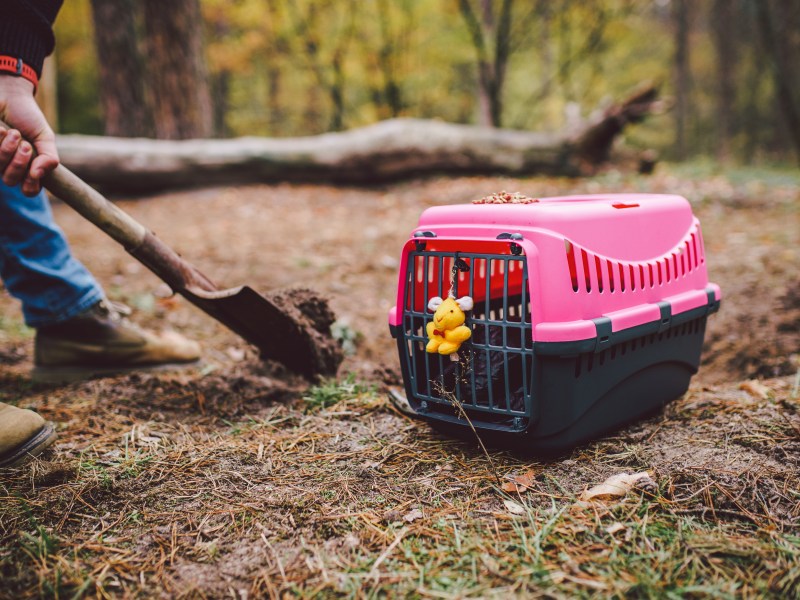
left=0, top=181, right=104, bottom=327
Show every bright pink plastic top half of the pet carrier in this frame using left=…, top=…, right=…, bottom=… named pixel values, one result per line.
left=390, top=194, right=721, bottom=342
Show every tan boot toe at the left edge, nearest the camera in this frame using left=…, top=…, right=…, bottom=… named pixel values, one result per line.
left=0, top=402, right=56, bottom=468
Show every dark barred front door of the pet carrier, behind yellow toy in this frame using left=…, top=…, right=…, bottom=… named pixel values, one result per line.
left=400, top=250, right=534, bottom=428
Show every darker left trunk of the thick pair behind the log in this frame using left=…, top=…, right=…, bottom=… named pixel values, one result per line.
left=92, top=0, right=153, bottom=137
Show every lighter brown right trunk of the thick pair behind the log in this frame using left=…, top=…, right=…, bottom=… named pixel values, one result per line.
left=142, top=0, right=213, bottom=140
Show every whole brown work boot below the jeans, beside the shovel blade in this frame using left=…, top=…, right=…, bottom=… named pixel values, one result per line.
left=32, top=300, right=200, bottom=383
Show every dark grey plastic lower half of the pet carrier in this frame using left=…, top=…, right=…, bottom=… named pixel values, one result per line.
left=393, top=290, right=719, bottom=455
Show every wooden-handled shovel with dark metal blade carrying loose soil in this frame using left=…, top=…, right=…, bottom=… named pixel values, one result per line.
left=35, top=165, right=342, bottom=378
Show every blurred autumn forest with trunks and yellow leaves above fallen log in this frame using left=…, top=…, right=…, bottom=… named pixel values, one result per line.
left=50, top=0, right=800, bottom=163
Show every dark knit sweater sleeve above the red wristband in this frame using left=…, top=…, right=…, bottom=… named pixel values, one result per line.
left=0, top=0, right=64, bottom=75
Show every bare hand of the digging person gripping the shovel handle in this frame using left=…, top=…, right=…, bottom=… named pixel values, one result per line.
left=0, top=74, right=59, bottom=196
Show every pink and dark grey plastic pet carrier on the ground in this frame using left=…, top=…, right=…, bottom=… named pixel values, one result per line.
left=389, top=194, right=721, bottom=453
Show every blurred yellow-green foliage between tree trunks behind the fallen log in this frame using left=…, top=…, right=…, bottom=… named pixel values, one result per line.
left=56, top=0, right=800, bottom=160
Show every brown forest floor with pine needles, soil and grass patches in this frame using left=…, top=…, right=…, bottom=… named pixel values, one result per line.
left=0, top=167, right=800, bottom=598
